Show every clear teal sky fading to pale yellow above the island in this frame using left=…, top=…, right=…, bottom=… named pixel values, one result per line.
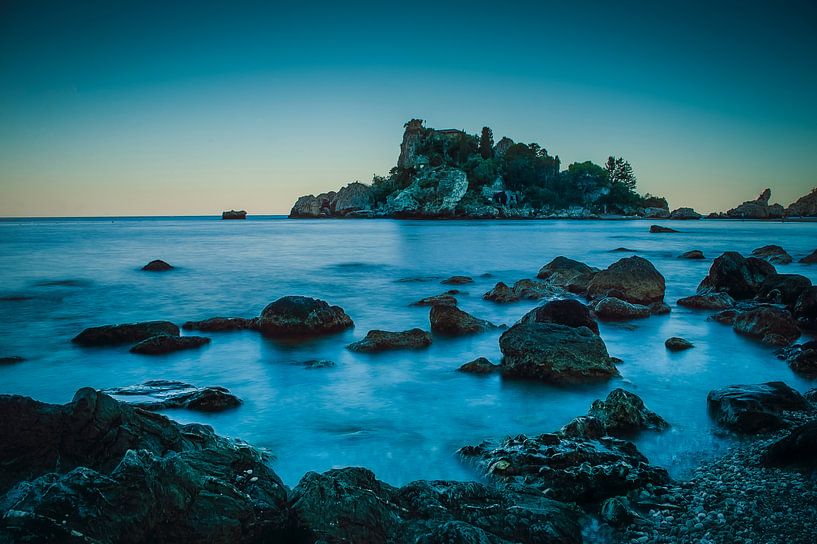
left=0, top=0, right=817, bottom=216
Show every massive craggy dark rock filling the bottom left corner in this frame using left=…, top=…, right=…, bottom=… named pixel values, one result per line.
left=0, top=388, right=288, bottom=544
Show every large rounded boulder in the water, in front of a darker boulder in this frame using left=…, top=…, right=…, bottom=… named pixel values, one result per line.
left=499, top=322, right=618, bottom=383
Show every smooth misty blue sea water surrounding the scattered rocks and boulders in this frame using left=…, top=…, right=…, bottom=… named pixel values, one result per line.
left=0, top=218, right=817, bottom=485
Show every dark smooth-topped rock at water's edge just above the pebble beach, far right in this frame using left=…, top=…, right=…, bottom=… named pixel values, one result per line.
left=706, top=382, right=810, bottom=434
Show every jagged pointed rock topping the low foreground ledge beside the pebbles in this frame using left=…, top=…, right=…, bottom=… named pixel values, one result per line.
left=587, top=388, right=669, bottom=437
